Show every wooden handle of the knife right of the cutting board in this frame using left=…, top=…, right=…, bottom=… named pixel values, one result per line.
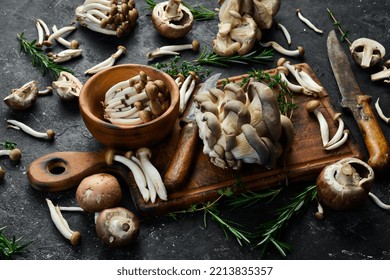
left=357, top=95, right=389, bottom=171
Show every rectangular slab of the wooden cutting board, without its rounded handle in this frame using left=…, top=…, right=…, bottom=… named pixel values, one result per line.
left=130, top=63, right=361, bottom=215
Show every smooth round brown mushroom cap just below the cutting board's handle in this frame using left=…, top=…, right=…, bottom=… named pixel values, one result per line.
left=76, top=173, right=122, bottom=212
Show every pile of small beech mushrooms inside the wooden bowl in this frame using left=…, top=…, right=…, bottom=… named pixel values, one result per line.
left=103, top=71, right=170, bottom=126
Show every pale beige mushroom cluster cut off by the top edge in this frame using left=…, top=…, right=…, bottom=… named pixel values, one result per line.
left=213, top=0, right=280, bottom=56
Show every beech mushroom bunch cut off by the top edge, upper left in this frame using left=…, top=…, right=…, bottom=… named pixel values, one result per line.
left=76, top=0, right=138, bottom=38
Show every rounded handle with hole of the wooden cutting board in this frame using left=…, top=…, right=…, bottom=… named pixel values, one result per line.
left=27, top=152, right=110, bottom=192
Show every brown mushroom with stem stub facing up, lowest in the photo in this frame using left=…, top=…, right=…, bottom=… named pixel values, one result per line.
left=96, top=207, right=140, bottom=248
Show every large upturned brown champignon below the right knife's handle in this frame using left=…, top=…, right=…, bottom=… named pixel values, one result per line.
left=317, top=158, right=374, bottom=210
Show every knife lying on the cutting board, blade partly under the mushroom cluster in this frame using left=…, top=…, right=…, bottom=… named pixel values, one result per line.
left=164, top=73, right=221, bottom=192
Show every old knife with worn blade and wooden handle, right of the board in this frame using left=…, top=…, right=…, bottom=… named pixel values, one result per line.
left=327, top=30, right=389, bottom=170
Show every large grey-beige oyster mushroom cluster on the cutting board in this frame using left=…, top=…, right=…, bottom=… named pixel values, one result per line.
left=194, top=80, right=294, bottom=169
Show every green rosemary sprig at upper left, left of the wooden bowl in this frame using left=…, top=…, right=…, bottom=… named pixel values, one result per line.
left=18, top=33, right=73, bottom=78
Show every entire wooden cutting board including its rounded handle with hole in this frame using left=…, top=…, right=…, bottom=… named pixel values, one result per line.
left=27, top=64, right=361, bottom=216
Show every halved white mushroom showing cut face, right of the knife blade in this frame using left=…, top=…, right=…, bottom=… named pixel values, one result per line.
left=349, top=38, right=386, bottom=68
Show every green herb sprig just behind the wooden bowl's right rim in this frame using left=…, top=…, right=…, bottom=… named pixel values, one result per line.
left=153, top=56, right=212, bottom=79
